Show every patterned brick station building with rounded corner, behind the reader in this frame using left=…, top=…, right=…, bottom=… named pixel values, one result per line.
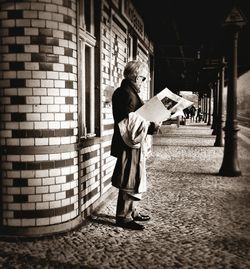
left=0, top=0, right=154, bottom=236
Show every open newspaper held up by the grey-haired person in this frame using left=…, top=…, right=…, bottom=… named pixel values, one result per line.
left=136, top=88, right=193, bottom=122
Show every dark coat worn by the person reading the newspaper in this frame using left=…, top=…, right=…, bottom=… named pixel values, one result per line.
left=111, top=79, right=155, bottom=191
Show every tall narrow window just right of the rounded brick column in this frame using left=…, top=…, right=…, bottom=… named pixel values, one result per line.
left=78, top=0, right=97, bottom=139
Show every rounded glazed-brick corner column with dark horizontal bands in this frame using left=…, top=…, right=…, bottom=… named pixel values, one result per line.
left=0, top=0, right=79, bottom=235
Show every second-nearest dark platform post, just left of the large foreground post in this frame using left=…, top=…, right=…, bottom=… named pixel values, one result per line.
left=214, top=57, right=225, bottom=147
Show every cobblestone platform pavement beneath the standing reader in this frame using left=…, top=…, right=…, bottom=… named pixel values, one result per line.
left=0, top=124, right=250, bottom=269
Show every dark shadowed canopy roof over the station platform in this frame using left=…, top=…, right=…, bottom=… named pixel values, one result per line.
left=133, top=0, right=250, bottom=92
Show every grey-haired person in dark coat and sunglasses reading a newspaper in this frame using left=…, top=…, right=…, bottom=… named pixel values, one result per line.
left=111, top=61, right=160, bottom=230
